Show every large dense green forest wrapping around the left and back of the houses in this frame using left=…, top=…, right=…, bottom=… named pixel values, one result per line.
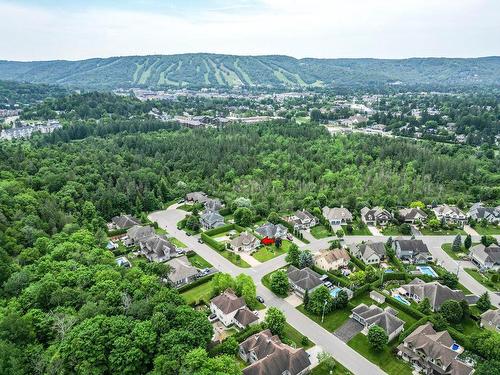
left=0, top=120, right=500, bottom=375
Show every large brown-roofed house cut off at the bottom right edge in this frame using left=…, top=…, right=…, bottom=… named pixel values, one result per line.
left=398, top=323, right=474, bottom=375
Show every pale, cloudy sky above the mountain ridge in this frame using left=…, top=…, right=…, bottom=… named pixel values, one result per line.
left=0, top=0, right=500, bottom=61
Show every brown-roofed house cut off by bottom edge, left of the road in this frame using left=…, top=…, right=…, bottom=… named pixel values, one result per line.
left=239, top=329, right=311, bottom=375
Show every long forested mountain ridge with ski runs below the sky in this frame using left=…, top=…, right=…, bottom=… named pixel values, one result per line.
left=0, top=53, right=500, bottom=89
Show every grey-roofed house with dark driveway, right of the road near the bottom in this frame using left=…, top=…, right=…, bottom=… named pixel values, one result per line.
left=351, top=303, right=405, bottom=341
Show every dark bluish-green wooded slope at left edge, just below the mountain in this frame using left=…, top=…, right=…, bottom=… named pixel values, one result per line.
left=0, top=81, right=68, bottom=109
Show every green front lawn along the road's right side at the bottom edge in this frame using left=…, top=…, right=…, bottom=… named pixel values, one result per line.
left=347, top=333, right=412, bottom=375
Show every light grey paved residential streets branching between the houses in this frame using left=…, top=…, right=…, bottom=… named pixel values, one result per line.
left=149, top=205, right=500, bottom=374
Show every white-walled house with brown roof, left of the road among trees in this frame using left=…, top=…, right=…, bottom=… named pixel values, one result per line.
left=210, top=289, right=259, bottom=329
